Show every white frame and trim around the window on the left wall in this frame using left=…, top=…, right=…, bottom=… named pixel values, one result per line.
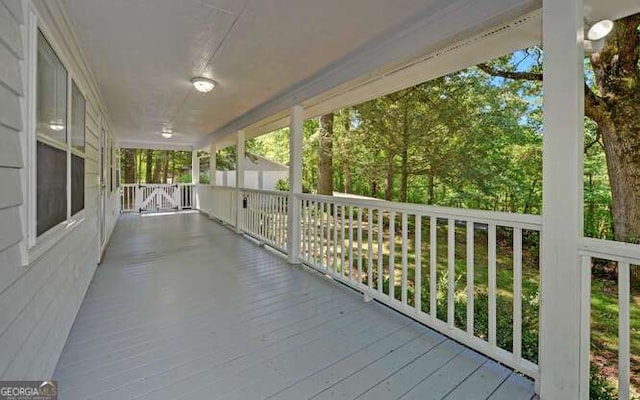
left=21, top=12, right=89, bottom=267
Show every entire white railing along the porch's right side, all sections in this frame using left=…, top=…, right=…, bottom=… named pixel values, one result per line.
left=192, top=185, right=640, bottom=399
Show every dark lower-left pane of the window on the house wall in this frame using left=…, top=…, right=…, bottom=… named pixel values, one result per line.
left=36, top=142, right=67, bottom=236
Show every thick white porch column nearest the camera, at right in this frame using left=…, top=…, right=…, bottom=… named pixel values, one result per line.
left=539, top=0, right=588, bottom=400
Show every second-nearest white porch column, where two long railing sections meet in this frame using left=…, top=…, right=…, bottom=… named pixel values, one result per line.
left=287, top=106, right=304, bottom=264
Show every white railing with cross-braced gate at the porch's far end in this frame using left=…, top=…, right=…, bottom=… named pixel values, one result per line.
left=120, top=183, right=195, bottom=212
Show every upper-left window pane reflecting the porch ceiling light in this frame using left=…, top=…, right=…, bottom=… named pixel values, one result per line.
left=36, top=31, right=67, bottom=142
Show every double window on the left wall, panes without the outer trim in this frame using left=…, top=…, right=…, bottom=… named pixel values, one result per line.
left=35, top=31, right=86, bottom=236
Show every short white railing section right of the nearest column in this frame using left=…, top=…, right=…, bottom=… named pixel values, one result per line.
left=580, top=238, right=640, bottom=400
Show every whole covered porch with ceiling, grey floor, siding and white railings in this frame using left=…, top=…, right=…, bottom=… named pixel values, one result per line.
left=0, top=0, right=640, bottom=400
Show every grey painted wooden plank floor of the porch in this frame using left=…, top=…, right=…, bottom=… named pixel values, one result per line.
left=54, top=214, right=533, bottom=400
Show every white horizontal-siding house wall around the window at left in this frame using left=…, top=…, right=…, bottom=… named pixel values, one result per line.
left=0, top=0, right=117, bottom=380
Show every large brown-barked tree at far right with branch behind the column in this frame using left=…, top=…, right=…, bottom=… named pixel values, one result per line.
left=480, top=13, right=640, bottom=241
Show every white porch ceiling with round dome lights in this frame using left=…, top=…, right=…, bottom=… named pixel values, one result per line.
left=59, top=0, right=631, bottom=146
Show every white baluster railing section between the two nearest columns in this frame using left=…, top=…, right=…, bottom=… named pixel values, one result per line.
left=299, top=195, right=541, bottom=379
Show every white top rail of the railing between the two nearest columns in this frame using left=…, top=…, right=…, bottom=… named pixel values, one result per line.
left=297, top=194, right=542, bottom=231
